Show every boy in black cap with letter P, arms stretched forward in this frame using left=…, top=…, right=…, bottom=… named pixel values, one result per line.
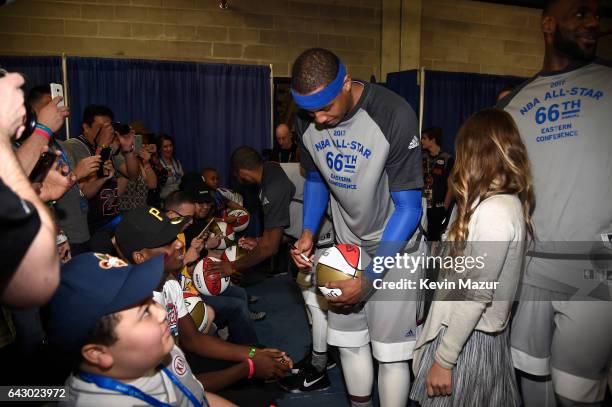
left=89, top=207, right=292, bottom=389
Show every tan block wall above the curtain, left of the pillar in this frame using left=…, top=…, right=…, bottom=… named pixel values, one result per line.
left=0, top=0, right=381, bottom=79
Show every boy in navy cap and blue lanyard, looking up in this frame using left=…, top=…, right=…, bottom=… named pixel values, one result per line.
left=49, top=253, right=233, bottom=407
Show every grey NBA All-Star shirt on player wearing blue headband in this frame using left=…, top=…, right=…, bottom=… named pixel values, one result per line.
left=296, top=82, right=423, bottom=247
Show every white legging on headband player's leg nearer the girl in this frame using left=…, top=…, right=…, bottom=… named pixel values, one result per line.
left=378, top=361, right=410, bottom=407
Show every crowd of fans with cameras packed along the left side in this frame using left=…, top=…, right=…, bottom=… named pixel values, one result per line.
left=0, top=72, right=292, bottom=405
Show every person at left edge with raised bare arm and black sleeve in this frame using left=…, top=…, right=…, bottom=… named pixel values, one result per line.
left=0, top=73, right=59, bottom=310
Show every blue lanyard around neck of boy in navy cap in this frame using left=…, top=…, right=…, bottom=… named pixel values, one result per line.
left=79, top=366, right=209, bottom=407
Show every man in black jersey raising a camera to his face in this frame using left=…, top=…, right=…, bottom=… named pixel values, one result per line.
left=64, top=105, right=139, bottom=234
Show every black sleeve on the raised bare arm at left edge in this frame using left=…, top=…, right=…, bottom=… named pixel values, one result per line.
left=0, top=180, right=40, bottom=280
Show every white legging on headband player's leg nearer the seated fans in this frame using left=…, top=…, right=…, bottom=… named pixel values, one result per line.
left=338, top=344, right=374, bottom=397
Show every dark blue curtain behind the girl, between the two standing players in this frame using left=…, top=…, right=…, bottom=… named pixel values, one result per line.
left=423, top=71, right=525, bottom=154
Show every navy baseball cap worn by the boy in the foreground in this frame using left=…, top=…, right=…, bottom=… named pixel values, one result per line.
left=47, top=252, right=164, bottom=351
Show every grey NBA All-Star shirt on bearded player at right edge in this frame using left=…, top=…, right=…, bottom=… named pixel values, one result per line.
left=498, top=62, right=612, bottom=292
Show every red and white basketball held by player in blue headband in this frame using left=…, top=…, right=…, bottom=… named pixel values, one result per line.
left=315, top=244, right=370, bottom=298
